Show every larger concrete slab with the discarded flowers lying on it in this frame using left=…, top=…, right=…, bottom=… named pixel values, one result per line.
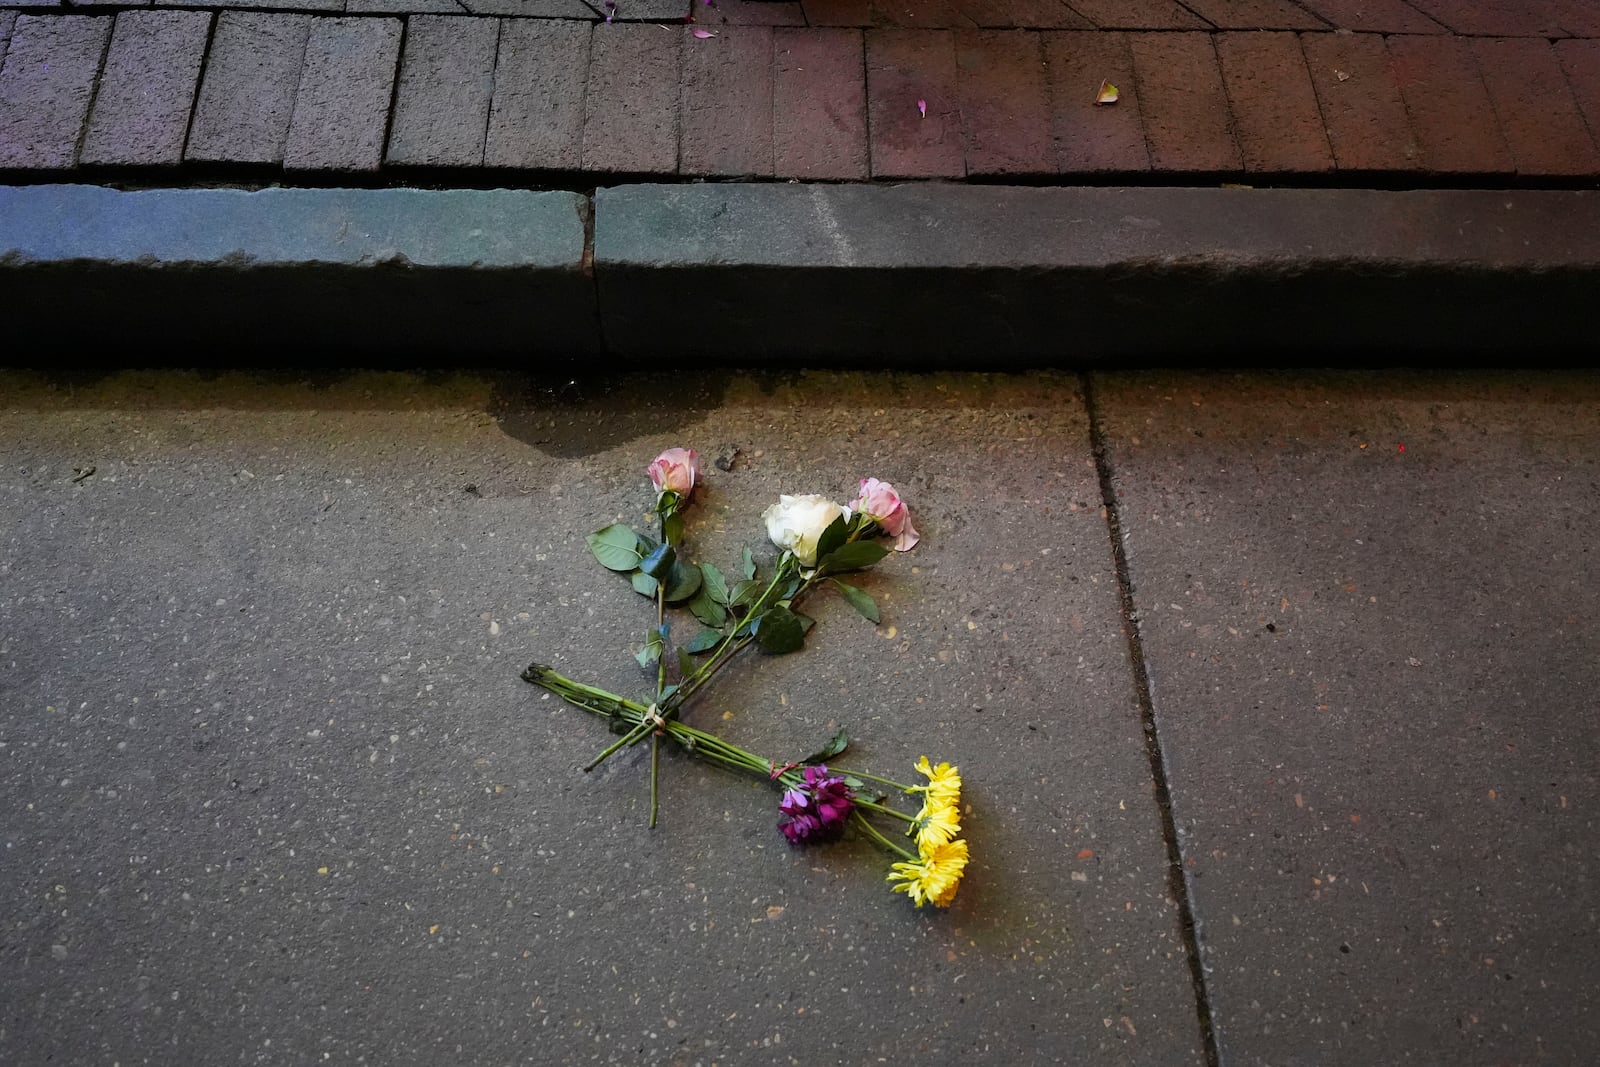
left=0, top=371, right=1203, bottom=1064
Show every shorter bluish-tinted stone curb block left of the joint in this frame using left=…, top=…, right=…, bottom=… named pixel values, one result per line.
left=0, top=186, right=598, bottom=363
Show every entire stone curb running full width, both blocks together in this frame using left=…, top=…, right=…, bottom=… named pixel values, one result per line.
left=0, top=184, right=1600, bottom=368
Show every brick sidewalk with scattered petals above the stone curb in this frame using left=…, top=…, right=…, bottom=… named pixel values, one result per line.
left=0, top=0, right=1600, bottom=186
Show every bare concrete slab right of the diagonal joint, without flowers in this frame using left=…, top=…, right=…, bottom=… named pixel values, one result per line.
left=1094, top=374, right=1600, bottom=1065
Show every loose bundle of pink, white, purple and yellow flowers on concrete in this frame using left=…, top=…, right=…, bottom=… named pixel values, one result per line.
left=522, top=448, right=968, bottom=907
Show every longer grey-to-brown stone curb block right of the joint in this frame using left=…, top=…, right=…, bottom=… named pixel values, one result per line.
left=595, top=184, right=1600, bottom=366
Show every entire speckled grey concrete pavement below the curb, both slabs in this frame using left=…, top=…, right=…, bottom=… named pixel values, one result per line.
left=0, top=371, right=1600, bottom=1064
